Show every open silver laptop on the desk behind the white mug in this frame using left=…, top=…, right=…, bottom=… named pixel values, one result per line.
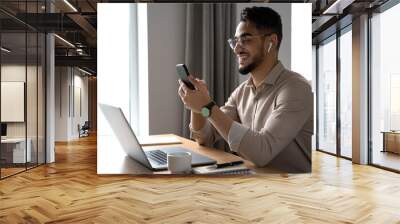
left=99, top=104, right=217, bottom=171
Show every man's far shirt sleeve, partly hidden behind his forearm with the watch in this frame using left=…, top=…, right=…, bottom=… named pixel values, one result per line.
left=189, top=87, right=240, bottom=147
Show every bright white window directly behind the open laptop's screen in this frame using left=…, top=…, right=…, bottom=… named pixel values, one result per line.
left=97, top=3, right=149, bottom=135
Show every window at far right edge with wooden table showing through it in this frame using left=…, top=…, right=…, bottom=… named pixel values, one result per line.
left=370, top=4, right=400, bottom=170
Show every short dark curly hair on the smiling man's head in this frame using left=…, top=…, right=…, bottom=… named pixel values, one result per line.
left=240, top=6, right=282, bottom=49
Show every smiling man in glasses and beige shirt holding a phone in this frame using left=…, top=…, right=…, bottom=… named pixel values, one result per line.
left=178, top=7, right=313, bottom=172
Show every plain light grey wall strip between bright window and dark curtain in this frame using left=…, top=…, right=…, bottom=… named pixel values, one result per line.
left=147, top=4, right=186, bottom=134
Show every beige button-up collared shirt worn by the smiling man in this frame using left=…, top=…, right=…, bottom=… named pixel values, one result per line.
left=190, top=62, right=314, bottom=173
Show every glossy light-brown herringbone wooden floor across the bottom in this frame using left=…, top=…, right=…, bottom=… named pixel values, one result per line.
left=0, top=134, right=400, bottom=223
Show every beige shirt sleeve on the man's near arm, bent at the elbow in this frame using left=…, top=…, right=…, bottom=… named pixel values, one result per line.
left=233, top=81, right=313, bottom=167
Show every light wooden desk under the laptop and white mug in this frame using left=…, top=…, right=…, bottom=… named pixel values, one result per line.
left=97, top=135, right=281, bottom=175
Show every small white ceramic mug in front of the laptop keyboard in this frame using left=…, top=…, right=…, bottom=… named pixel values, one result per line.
left=167, top=152, right=192, bottom=174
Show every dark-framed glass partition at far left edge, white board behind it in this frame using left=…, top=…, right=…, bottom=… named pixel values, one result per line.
left=0, top=1, right=46, bottom=178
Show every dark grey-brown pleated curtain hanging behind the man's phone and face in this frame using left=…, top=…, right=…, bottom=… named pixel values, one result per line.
left=181, top=3, right=238, bottom=149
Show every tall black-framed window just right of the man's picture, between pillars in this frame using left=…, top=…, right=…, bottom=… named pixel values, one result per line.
left=316, top=24, right=353, bottom=159
